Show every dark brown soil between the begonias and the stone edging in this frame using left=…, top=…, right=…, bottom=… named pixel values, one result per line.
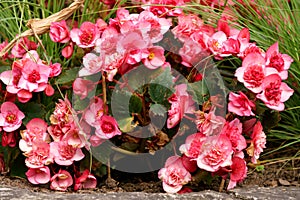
left=0, top=160, right=300, bottom=193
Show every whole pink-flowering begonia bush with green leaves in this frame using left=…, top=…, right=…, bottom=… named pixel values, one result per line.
left=0, top=0, right=294, bottom=193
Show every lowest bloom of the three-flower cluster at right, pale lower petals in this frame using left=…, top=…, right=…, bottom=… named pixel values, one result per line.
left=256, top=74, right=294, bottom=111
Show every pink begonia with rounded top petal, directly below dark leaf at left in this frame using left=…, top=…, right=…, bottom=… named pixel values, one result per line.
left=19, top=118, right=50, bottom=152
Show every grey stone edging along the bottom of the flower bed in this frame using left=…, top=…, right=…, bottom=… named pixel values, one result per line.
left=0, top=185, right=300, bottom=200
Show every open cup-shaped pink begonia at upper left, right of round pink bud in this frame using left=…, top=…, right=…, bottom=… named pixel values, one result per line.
left=70, top=22, right=100, bottom=48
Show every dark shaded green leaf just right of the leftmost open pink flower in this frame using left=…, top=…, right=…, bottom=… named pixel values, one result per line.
left=18, top=102, right=46, bottom=125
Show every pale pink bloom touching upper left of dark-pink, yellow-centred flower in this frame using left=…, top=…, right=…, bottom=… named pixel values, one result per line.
left=83, top=97, right=108, bottom=127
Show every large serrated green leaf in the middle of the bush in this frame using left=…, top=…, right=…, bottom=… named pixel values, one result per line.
left=149, top=68, right=174, bottom=105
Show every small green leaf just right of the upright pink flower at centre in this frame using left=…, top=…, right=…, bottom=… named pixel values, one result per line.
left=187, top=81, right=209, bottom=105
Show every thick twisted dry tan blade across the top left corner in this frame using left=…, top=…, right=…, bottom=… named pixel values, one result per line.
left=0, top=0, right=84, bottom=57
